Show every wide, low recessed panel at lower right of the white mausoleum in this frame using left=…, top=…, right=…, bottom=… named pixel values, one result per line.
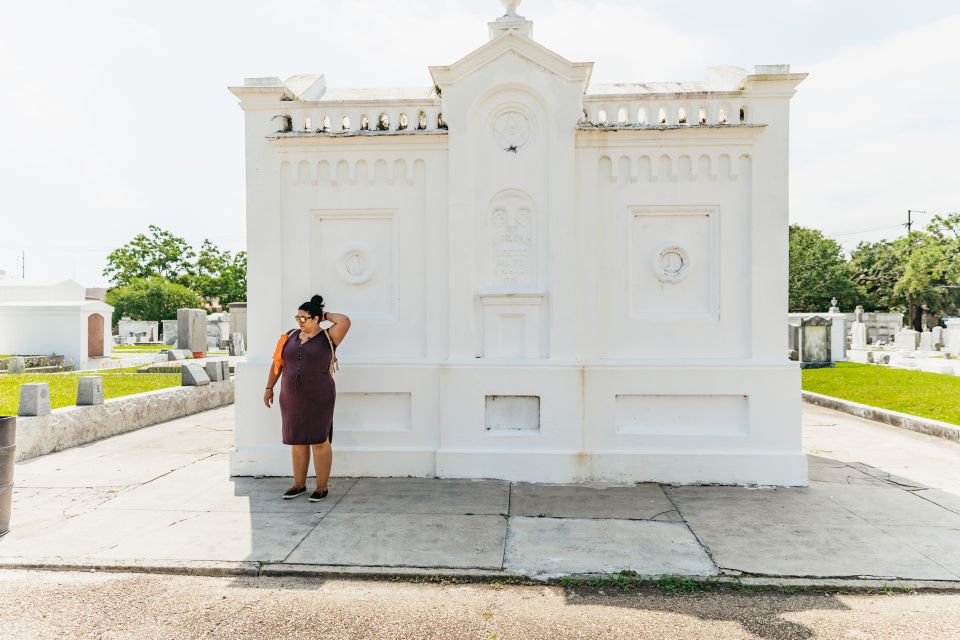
left=615, top=394, right=749, bottom=436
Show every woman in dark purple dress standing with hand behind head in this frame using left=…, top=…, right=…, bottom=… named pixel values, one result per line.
left=263, top=296, right=350, bottom=502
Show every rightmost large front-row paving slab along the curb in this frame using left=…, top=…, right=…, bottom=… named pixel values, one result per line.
left=691, top=520, right=955, bottom=580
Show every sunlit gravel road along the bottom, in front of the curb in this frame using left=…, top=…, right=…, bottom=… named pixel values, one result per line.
left=0, top=571, right=960, bottom=640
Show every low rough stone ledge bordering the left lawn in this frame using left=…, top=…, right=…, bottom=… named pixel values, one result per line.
left=15, top=380, right=233, bottom=462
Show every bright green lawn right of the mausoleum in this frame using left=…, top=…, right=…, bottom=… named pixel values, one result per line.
left=802, top=362, right=960, bottom=424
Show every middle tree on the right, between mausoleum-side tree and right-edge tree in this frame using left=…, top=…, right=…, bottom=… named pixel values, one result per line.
left=850, top=238, right=907, bottom=311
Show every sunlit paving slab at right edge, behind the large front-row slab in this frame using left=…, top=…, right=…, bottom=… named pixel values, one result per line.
left=828, top=485, right=960, bottom=529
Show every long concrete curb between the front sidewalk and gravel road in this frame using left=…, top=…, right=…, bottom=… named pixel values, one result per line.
left=0, top=558, right=960, bottom=591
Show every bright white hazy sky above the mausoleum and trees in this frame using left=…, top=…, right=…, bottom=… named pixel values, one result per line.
left=0, top=0, right=960, bottom=286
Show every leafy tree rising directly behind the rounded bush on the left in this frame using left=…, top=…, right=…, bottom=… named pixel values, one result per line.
left=103, top=225, right=196, bottom=287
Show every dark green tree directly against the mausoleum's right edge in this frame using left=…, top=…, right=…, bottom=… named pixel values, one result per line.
left=789, top=224, right=862, bottom=311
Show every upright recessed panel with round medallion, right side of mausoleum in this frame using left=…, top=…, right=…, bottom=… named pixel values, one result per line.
left=628, top=207, right=719, bottom=319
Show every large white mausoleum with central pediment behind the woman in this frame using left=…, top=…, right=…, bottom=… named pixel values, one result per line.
left=231, top=2, right=807, bottom=485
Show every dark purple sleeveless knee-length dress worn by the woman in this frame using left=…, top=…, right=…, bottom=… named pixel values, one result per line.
left=280, top=329, right=337, bottom=444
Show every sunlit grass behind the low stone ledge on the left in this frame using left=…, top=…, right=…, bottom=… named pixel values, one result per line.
left=0, top=367, right=180, bottom=416
